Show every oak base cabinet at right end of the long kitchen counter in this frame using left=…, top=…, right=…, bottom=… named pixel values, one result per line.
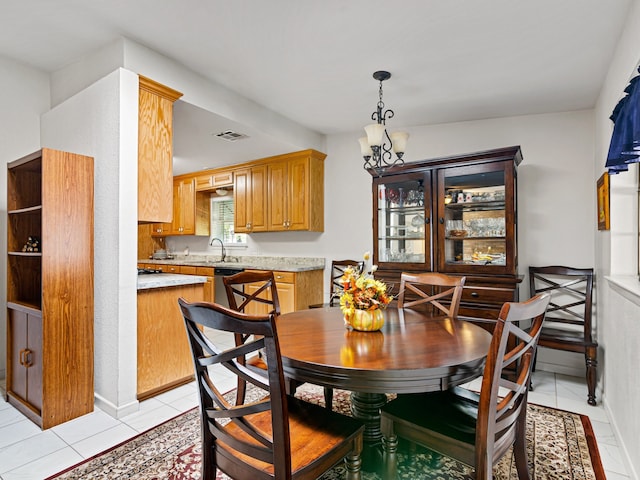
left=245, top=270, right=324, bottom=315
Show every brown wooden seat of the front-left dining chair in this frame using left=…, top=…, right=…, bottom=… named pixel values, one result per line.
left=218, top=396, right=364, bottom=478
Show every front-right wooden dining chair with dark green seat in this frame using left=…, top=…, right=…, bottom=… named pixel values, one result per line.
left=381, top=293, right=550, bottom=480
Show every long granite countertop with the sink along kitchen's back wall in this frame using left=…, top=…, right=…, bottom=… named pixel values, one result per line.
left=138, top=255, right=325, bottom=272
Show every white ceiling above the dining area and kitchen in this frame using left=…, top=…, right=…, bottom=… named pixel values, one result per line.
left=0, top=0, right=636, bottom=173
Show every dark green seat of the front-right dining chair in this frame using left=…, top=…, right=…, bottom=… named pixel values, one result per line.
left=382, top=387, right=480, bottom=445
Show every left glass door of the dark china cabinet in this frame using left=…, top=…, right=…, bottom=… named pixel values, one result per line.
left=374, top=174, right=431, bottom=269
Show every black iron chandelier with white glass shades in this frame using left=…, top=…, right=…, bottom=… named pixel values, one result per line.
left=359, top=70, right=409, bottom=172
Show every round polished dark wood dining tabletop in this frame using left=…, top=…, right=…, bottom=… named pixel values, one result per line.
left=276, top=307, right=491, bottom=393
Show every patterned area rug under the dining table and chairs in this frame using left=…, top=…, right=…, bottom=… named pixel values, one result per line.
left=47, top=384, right=606, bottom=480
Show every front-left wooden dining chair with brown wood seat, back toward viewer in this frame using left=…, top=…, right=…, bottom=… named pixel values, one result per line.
left=178, top=298, right=364, bottom=480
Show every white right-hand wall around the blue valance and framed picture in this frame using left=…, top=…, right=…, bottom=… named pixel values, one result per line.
left=594, top=2, right=640, bottom=479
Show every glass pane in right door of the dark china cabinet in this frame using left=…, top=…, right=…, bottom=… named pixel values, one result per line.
left=444, top=170, right=507, bottom=265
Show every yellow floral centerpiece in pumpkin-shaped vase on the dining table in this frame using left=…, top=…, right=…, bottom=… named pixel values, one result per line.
left=340, top=252, right=393, bottom=331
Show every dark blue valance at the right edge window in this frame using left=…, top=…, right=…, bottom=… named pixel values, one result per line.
left=605, top=68, right=640, bottom=175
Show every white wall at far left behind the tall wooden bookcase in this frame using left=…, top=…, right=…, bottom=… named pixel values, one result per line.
left=0, top=56, right=49, bottom=378
